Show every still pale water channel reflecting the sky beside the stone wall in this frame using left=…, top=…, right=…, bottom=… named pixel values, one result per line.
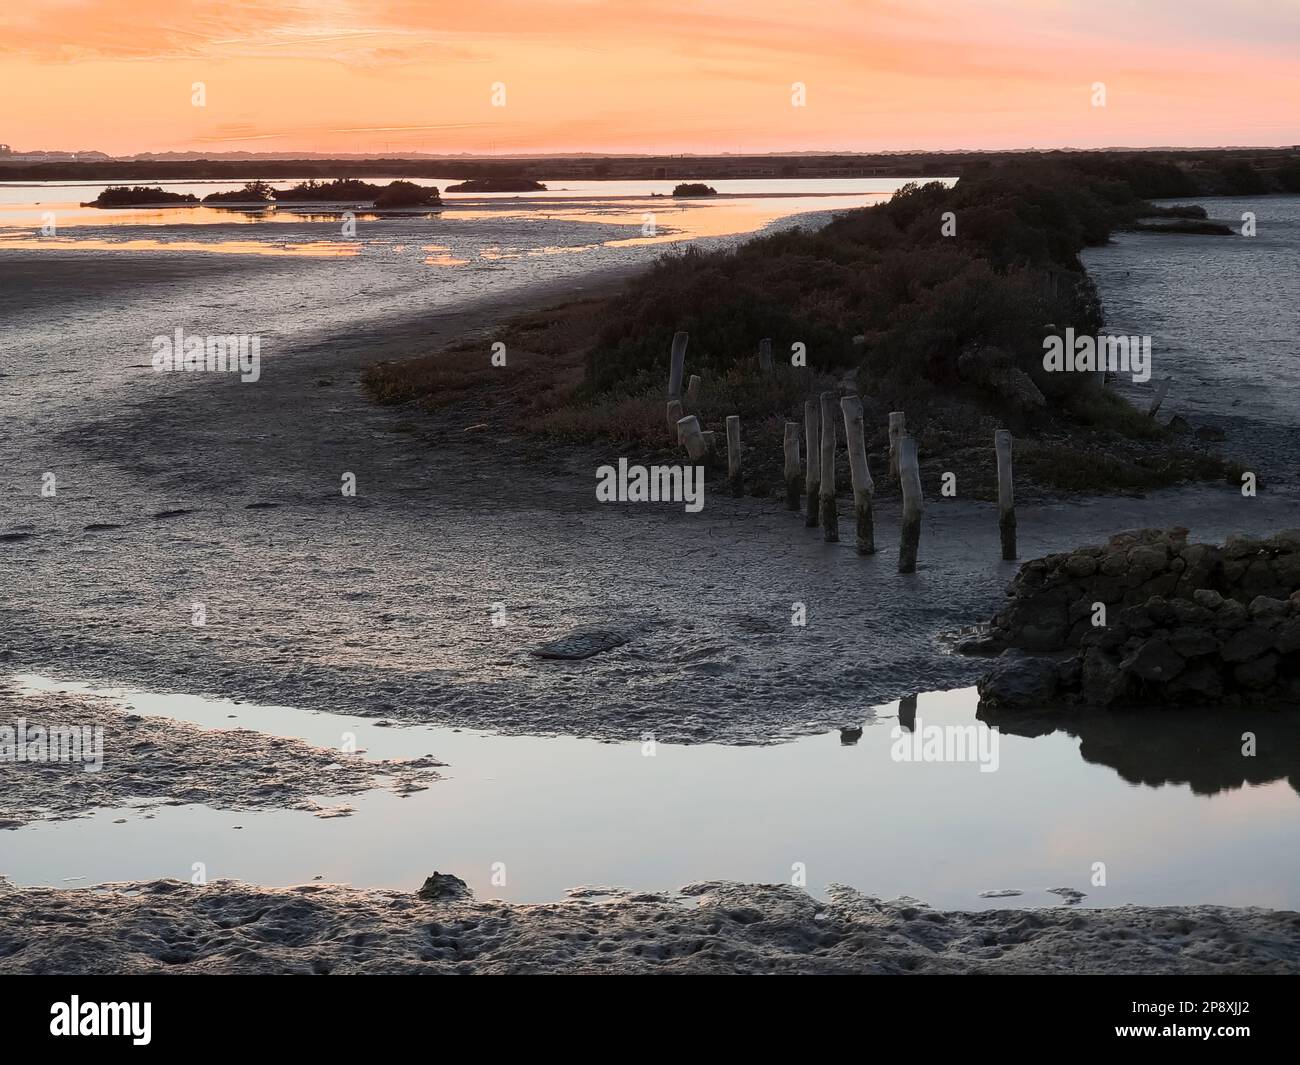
left=4, top=677, right=1300, bottom=909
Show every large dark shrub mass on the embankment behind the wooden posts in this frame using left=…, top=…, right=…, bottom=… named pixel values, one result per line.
left=586, top=164, right=1149, bottom=414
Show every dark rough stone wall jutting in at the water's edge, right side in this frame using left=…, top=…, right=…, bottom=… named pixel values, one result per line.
left=961, top=528, right=1300, bottom=709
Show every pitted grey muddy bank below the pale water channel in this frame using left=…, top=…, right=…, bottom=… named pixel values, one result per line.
left=0, top=880, right=1300, bottom=975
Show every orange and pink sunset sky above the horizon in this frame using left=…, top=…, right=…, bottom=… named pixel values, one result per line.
left=0, top=0, right=1300, bottom=155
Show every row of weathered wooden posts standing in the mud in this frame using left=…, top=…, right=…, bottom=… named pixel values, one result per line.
left=668, top=333, right=1013, bottom=573
